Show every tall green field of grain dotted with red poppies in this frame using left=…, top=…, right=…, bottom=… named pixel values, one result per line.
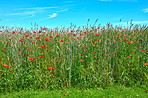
left=0, top=24, right=148, bottom=97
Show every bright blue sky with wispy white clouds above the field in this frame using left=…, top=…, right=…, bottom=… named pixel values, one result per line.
left=0, top=0, right=148, bottom=28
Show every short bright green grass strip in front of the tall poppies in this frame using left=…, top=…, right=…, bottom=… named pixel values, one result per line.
left=0, top=87, right=148, bottom=98
